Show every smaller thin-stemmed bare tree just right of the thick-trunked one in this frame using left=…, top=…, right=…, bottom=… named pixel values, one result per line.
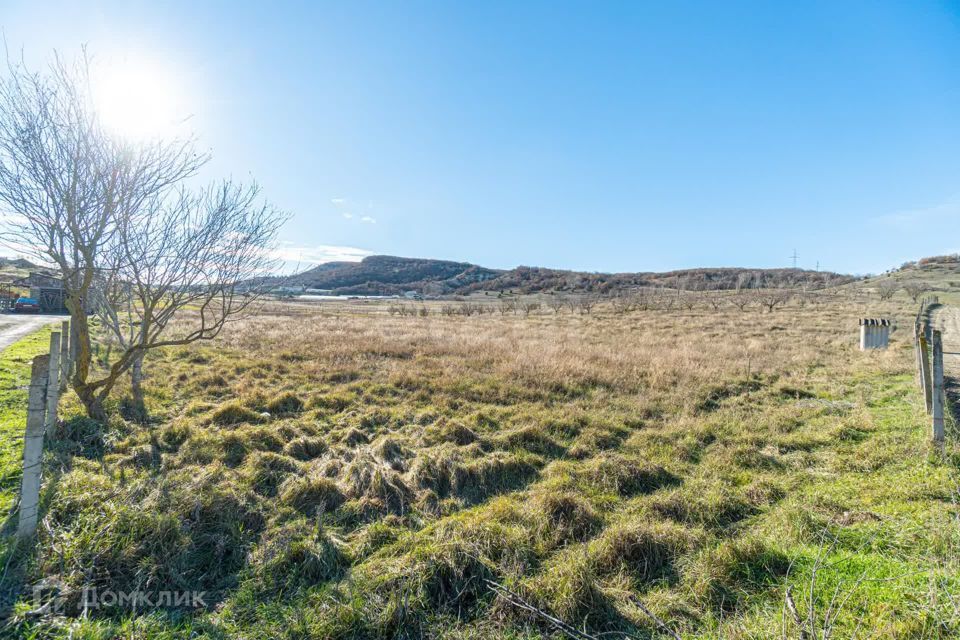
left=96, top=182, right=284, bottom=416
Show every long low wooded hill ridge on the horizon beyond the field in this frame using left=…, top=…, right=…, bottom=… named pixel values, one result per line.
left=286, top=256, right=855, bottom=296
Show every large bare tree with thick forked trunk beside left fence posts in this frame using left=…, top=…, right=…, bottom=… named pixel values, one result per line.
left=0, top=54, right=283, bottom=419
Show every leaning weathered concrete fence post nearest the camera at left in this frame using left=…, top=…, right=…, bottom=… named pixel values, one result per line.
left=17, top=355, right=50, bottom=538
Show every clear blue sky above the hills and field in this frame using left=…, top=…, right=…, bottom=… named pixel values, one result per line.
left=0, top=0, right=960, bottom=273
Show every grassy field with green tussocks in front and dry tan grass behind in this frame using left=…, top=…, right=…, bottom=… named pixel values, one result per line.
left=1, top=299, right=960, bottom=639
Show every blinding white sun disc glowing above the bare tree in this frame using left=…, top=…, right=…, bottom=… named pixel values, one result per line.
left=91, top=60, right=186, bottom=140
